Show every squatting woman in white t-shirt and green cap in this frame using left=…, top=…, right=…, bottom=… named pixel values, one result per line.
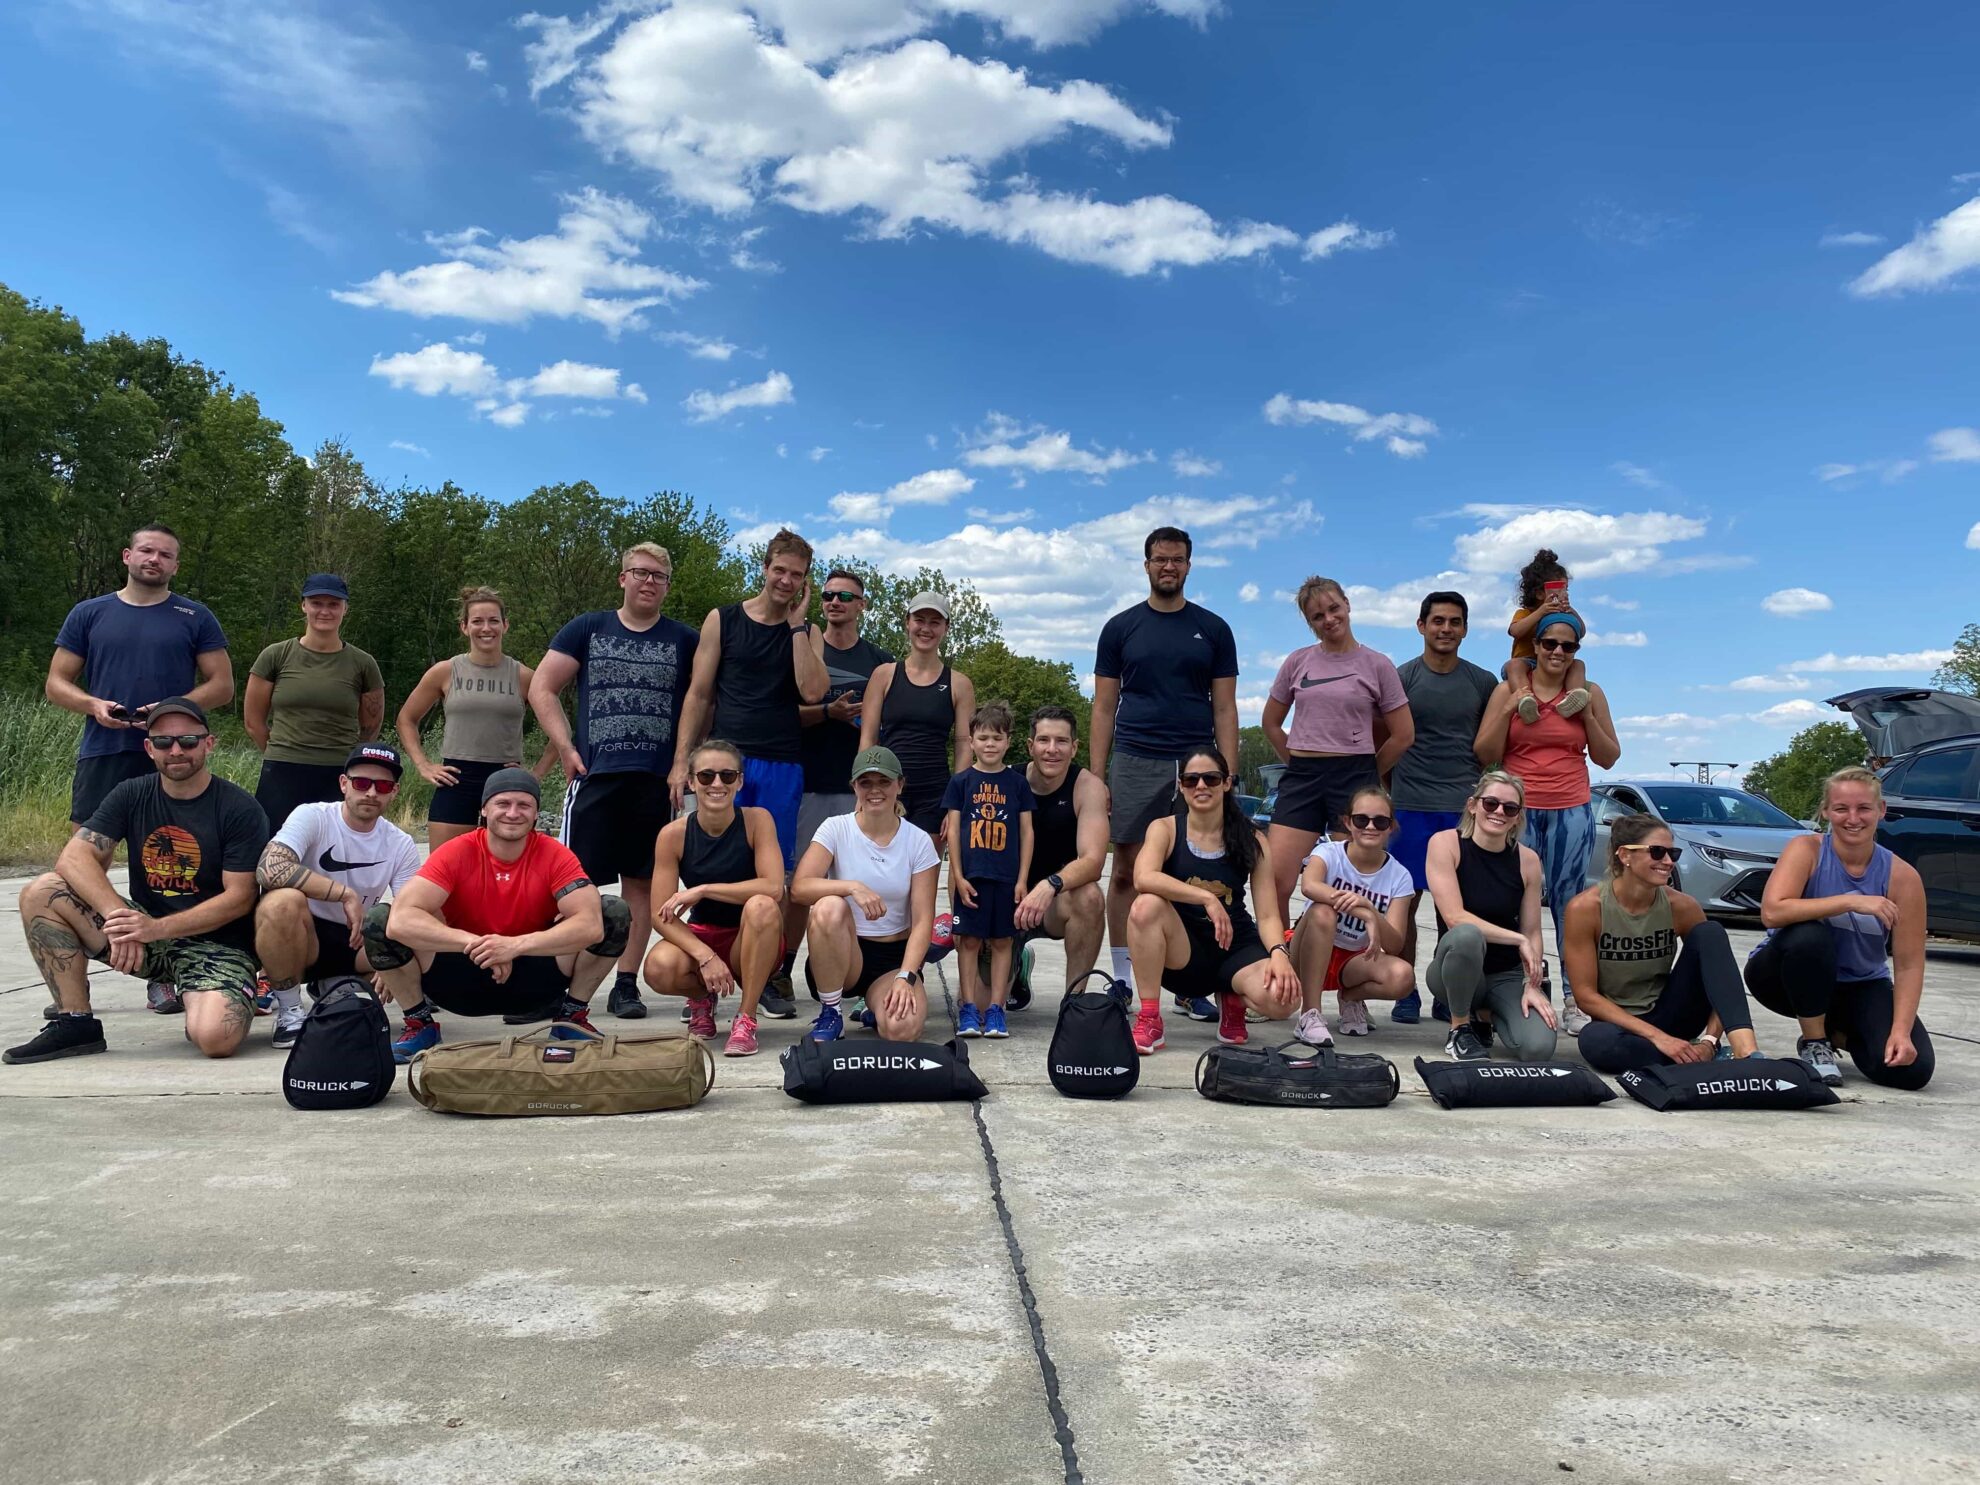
left=790, top=748, right=939, bottom=1041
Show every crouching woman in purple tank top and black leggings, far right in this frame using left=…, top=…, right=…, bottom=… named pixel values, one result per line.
left=1746, top=768, right=1934, bottom=1089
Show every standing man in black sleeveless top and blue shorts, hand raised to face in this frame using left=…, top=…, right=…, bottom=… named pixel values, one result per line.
left=667, top=531, right=832, bottom=1020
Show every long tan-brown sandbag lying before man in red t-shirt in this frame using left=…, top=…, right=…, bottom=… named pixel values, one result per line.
left=406, top=1022, right=715, bottom=1119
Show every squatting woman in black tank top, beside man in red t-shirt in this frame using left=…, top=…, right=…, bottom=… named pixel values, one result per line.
left=642, top=739, right=784, bottom=1057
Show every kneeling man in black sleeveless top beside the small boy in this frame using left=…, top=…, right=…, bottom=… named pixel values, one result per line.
left=1014, top=707, right=1125, bottom=1004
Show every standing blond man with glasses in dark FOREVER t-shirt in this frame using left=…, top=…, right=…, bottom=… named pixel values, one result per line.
left=529, top=541, right=699, bottom=1018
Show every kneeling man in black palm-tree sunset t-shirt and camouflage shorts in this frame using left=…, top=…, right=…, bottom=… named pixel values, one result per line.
left=4, top=697, right=267, bottom=1063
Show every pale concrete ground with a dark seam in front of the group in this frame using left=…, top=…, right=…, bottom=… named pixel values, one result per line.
left=0, top=883, right=1980, bottom=1485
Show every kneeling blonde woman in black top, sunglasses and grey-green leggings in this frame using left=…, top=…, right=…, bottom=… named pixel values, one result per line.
left=1424, top=768, right=1554, bottom=1061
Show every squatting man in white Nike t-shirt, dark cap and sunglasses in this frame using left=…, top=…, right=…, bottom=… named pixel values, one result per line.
left=253, top=743, right=420, bottom=1047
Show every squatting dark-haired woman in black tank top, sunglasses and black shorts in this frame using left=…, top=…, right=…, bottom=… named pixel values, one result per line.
left=1127, top=748, right=1299, bottom=1057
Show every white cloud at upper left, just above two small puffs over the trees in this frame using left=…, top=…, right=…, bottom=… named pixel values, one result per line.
left=333, top=188, right=705, bottom=335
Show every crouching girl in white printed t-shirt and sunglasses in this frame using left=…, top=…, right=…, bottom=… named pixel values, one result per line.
left=1293, top=784, right=1416, bottom=1045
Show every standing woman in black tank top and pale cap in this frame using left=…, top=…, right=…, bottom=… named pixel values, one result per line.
left=859, top=592, right=976, bottom=851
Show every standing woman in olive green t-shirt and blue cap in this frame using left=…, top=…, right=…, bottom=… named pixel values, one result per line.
left=242, top=572, right=384, bottom=832
